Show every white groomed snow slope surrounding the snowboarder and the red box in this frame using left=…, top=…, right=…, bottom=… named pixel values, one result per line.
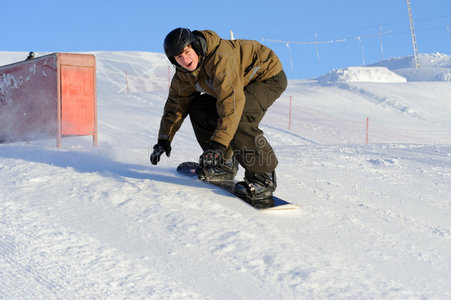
left=0, top=52, right=451, bottom=299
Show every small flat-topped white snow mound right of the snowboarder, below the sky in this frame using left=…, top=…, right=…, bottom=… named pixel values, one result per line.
left=318, top=67, right=407, bottom=84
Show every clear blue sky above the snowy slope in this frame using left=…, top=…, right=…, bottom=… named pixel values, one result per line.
left=0, top=0, right=451, bottom=79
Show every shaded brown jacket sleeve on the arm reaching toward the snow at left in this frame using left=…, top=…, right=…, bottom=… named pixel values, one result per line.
left=158, top=73, right=200, bottom=142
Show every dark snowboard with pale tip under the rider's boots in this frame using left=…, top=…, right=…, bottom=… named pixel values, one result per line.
left=177, top=162, right=300, bottom=211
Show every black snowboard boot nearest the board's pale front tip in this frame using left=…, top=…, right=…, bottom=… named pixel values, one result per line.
left=234, top=171, right=277, bottom=208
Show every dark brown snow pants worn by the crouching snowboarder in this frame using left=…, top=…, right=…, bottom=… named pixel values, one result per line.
left=189, top=71, right=287, bottom=178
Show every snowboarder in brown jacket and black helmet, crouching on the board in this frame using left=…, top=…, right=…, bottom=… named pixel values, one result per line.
left=150, top=28, right=287, bottom=206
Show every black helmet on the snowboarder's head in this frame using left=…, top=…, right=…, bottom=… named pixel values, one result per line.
left=164, top=28, right=200, bottom=65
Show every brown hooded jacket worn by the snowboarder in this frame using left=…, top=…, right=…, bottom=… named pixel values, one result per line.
left=158, top=30, right=282, bottom=146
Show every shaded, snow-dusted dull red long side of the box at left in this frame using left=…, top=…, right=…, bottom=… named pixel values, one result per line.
left=0, top=54, right=58, bottom=142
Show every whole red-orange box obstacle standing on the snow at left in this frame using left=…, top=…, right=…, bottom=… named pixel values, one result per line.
left=0, top=53, right=97, bottom=147
